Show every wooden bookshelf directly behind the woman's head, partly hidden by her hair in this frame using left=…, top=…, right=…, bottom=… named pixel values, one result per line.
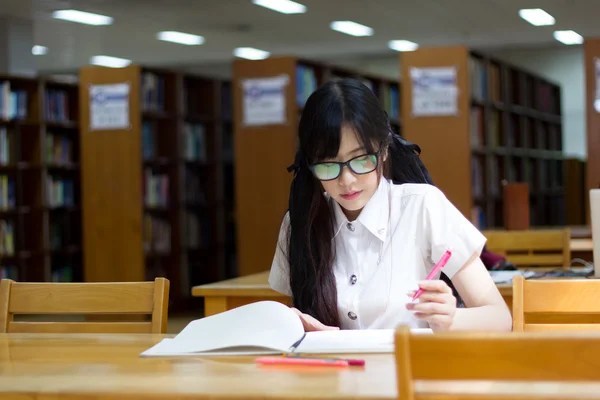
left=233, top=57, right=401, bottom=275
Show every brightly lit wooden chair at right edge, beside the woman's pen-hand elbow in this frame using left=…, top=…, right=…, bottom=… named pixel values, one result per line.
left=513, top=276, right=600, bottom=332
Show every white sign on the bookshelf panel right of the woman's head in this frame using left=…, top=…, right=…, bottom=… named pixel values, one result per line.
left=410, top=67, right=458, bottom=117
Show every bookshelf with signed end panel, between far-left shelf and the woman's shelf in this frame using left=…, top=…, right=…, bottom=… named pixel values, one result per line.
left=80, top=65, right=231, bottom=309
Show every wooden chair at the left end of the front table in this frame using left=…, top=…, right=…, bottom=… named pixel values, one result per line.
left=0, top=278, right=169, bottom=333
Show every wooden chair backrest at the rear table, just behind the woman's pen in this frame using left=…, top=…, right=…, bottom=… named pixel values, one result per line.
left=483, top=228, right=571, bottom=268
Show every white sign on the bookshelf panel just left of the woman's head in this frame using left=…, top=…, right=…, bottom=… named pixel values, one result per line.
left=242, top=75, right=289, bottom=126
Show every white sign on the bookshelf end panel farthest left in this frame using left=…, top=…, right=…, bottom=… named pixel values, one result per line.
left=89, top=83, right=130, bottom=130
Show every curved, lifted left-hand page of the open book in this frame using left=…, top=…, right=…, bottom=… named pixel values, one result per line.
left=142, top=301, right=304, bottom=356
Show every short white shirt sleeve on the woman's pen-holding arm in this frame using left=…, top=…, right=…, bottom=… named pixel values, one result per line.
left=423, top=186, right=486, bottom=278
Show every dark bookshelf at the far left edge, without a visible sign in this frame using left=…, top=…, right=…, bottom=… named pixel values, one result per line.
left=0, top=76, right=82, bottom=282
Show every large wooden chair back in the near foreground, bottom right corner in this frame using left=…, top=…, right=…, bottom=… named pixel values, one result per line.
left=395, top=326, right=600, bottom=400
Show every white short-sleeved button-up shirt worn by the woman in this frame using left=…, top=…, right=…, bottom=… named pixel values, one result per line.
left=269, top=178, right=486, bottom=329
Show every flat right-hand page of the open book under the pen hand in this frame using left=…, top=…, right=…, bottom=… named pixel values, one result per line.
left=294, top=329, right=432, bottom=354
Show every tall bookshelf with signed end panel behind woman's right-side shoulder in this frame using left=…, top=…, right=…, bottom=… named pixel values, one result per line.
left=400, top=46, right=566, bottom=229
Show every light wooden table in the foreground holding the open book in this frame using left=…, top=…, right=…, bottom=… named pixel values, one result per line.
left=0, top=334, right=600, bottom=400
